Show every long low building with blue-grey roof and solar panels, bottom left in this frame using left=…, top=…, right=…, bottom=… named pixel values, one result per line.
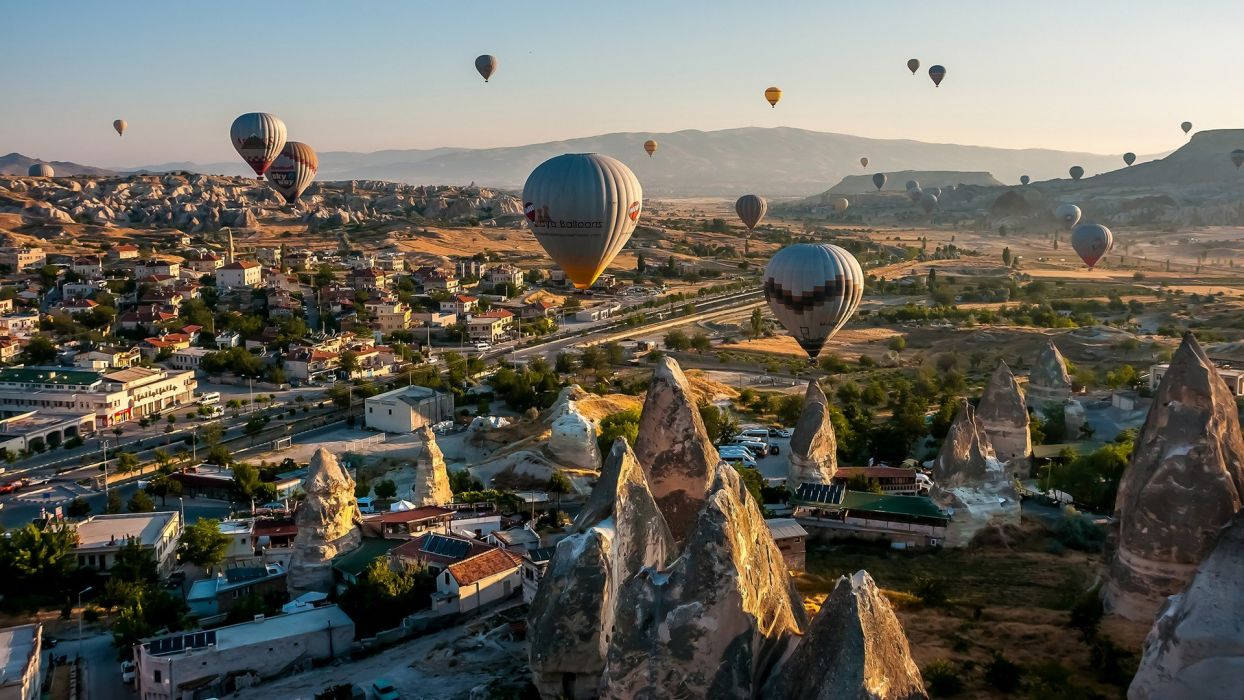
left=134, top=606, right=355, bottom=700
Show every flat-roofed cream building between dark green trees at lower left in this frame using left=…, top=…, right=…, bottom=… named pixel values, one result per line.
left=73, top=511, right=182, bottom=576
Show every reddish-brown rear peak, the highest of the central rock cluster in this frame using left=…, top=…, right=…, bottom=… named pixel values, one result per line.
left=634, top=357, right=722, bottom=542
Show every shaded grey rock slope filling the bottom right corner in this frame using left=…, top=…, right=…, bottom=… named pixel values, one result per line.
left=1127, top=511, right=1244, bottom=700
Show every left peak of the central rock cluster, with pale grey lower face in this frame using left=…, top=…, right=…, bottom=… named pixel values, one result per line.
left=527, top=440, right=674, bottom=700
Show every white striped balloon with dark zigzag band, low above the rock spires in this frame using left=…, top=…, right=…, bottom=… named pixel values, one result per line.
left=765, top=244, right=863, bottom=359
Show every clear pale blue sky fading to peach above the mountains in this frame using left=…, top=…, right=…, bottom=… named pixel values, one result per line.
left=0, top=0, right=1244, bottom=165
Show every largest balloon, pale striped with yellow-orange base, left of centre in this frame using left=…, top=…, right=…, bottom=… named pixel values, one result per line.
left=522, top=153, right=643, bottom=290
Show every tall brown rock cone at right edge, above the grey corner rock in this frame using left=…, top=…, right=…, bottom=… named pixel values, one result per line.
left=1103, top=333, right=1244, bottom=622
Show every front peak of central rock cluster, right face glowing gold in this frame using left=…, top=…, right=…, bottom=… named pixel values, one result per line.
left=605, top=464, right=807, bottom=699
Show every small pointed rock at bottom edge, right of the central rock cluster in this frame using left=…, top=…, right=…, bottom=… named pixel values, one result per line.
left=761, top=571, right=928, bottom=700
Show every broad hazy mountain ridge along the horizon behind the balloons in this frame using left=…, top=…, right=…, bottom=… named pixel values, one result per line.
left=121, top=127, right=1149, bottom=198
